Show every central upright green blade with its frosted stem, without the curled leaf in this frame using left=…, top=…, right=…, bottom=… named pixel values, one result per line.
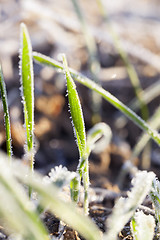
left=62, top=54, right=89, bottom=215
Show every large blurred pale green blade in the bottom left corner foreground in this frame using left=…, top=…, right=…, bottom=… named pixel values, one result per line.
left=0, top=154, right=49, bottom=240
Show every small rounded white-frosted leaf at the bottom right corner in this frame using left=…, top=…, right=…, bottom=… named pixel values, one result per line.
left=131, top=211, right=155, bottom=240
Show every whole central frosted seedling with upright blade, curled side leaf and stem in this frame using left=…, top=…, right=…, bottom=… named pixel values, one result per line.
left=62, top=55, right=112, bottom=214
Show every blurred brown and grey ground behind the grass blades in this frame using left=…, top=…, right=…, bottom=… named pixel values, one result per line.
left=0, top=0, right=160, bottom=239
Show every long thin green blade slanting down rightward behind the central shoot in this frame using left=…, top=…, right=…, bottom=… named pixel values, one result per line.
left=33, top=52, right=160, bottom=145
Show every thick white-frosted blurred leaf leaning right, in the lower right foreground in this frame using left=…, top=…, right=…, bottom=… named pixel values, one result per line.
left=106, top=171, right=155, bottom=240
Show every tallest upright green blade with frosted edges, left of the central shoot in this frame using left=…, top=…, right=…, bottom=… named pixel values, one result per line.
left=20, top=23, right=34, bottom=169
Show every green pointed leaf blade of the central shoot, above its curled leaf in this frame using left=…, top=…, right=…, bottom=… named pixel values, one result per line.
left=62, top=54, right=86, bottom=157
